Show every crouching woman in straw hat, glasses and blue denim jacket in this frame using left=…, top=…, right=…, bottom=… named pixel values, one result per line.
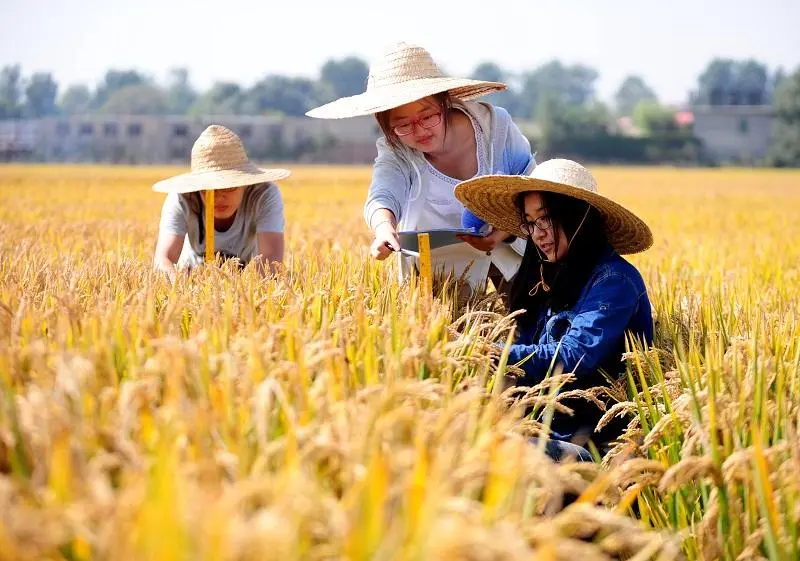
left=456, top=159, right=653, bottom=460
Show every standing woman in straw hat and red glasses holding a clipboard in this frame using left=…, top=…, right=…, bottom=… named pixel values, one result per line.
left=307, top=43, right=535, bottom=298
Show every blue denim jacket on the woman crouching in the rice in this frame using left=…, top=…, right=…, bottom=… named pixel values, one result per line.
left=509, top=246, right=653, bottom=438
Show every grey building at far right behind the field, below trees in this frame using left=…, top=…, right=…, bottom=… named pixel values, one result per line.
left=691, top=105, right=775, bottom=164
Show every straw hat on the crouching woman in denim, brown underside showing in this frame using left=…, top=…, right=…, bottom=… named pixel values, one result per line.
left=455, top=159, right=653, bottom=254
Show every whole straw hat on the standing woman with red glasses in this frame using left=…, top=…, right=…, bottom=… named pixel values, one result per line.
left=306, top=43, right=508, bottom=119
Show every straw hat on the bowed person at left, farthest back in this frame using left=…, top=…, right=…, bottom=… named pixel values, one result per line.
left=153, top=125, right=291, bottom=193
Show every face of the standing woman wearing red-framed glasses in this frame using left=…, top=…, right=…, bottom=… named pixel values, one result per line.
left=389, top=97, right=445, bottom=152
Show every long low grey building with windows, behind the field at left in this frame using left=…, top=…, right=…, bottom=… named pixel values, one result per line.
left=0, top=114, right=379, bottom=165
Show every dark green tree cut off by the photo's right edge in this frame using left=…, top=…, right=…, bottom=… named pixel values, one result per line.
left=767, top=66, right=800, bottom=167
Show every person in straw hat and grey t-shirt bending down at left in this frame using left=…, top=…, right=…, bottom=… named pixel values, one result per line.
left=153, top=125, right=290, bottom=278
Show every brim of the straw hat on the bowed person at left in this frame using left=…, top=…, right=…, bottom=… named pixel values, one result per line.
left=153, top=163, right=291, bottom=193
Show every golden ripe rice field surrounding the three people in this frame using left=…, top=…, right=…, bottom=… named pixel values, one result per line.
left=0, top=166, right=800, bottom=561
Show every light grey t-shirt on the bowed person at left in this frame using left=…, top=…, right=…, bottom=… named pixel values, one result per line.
left=159, top=183, right=284, bottom=265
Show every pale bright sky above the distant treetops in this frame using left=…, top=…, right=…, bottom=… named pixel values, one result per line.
left=0, top=0, right=800, bottom=103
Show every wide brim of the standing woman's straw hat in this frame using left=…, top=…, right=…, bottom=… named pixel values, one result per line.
left=306, top=76, right=508, bottom=119
